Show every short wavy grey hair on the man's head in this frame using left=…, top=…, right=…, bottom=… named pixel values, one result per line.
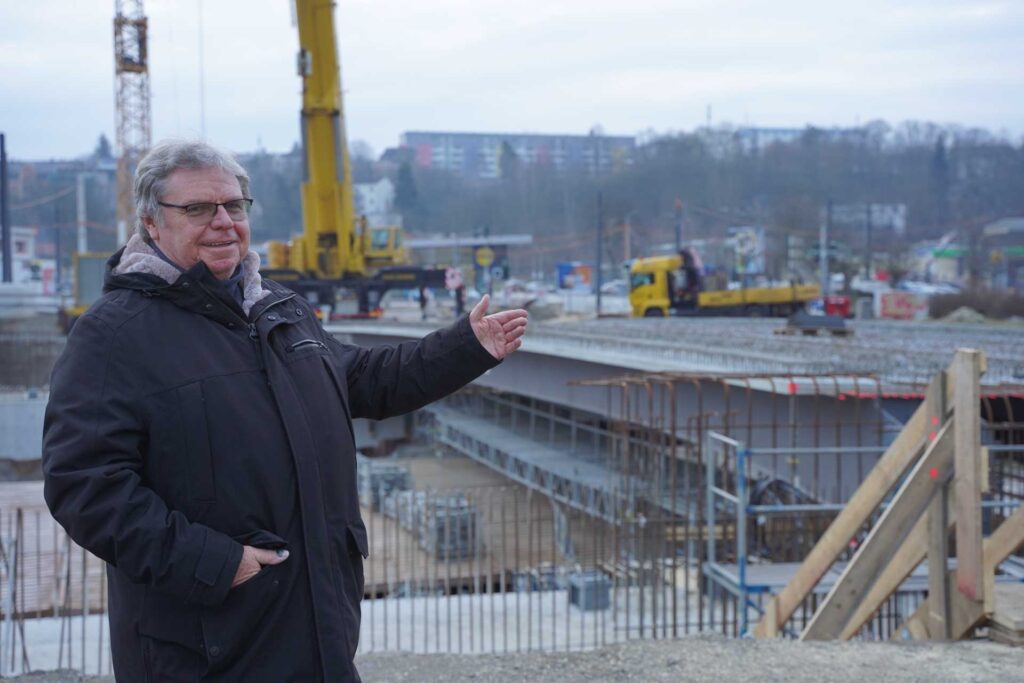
left=134, top=139, right=249, bottom=243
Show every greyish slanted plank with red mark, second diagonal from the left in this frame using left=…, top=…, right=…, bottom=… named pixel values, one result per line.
left=800, top=422, right=953, bottom=640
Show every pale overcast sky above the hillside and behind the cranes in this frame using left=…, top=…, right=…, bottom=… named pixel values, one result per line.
left=0, top=0, right=1024, bottom=159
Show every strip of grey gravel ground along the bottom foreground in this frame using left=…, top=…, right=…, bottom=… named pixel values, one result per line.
left=12, top=636, right=1024, bottom=683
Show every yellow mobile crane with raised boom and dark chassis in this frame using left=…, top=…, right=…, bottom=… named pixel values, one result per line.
left=263, top=0, right=444, bottom=315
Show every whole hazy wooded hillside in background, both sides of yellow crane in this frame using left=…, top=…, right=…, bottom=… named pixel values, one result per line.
left=14, top=122, right=1024, bottom=276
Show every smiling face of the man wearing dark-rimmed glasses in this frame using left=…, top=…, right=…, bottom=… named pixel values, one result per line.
left=144, top=168, right=249, bottom=280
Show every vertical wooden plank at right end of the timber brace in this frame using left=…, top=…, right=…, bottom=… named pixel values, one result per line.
left=952, top=349, right=984, bottom=600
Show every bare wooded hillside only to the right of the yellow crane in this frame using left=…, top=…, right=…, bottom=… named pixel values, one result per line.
left=389, top=122, right=1024, bottom=239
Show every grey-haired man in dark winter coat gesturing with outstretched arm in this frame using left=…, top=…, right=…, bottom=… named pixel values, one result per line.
left=43, top=141, right=526, bottom=682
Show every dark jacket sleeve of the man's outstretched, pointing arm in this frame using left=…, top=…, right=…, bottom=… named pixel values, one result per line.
left=328, top=315, right=500, bottom=420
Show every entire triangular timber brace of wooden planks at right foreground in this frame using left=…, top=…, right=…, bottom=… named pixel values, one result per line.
left=754, top=349, right=1024, bottom=640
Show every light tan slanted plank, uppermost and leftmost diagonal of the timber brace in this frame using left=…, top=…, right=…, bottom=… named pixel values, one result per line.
left=754, top=373, right=955, bottom=638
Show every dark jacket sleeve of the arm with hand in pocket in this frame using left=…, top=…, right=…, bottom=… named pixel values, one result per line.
left=43, top=314, right=242, bottom=605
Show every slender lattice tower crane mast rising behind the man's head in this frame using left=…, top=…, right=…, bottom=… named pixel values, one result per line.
left=114, top=0, right=152, bottom=244
